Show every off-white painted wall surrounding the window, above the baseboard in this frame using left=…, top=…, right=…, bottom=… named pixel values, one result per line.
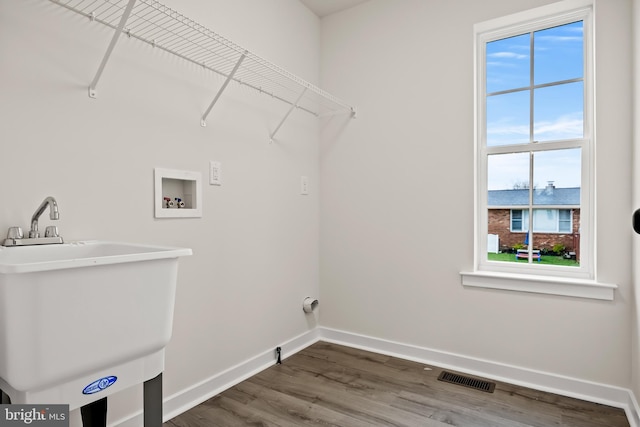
left=320, top=0, right=632, bottom=388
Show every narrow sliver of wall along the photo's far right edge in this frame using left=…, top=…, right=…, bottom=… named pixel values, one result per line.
left=631, top=0, right=640, bottom=400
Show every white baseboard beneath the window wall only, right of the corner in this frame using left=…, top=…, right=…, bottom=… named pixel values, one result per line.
left=319, top=328, right=640, bottom=427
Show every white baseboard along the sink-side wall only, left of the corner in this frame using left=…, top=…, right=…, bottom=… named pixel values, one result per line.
left=109, top=328, right=319, bottom=427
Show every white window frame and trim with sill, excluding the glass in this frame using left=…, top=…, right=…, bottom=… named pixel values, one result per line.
left=461, top=0, right=617, bottom=300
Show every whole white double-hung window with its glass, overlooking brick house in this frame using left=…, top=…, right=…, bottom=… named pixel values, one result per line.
left=462, top=0, right=615, bottom=299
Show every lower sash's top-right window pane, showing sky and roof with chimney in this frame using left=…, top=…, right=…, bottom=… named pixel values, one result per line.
left=533, top=148, right=582, bottom=206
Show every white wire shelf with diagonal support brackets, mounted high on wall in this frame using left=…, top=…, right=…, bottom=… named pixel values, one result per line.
left=51, top=0, right=355, bottom=138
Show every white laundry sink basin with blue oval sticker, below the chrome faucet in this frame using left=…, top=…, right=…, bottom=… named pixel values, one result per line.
left=0, top=241, right=191, bottom=409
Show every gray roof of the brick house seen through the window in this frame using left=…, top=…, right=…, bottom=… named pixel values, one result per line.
left=487, top=187, right=580, bottom=206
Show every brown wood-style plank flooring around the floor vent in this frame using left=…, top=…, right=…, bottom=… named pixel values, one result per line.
left=164, top=342, right=629, bottom=427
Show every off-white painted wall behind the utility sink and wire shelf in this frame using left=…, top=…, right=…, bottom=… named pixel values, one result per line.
left=0, top=0, right=319, bottom=422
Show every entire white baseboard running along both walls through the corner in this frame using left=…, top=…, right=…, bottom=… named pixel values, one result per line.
left=111, top=327, right=640, bottom=427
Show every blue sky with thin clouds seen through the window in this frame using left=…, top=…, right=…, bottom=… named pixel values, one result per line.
left=486, top=22, right=584, bottom=190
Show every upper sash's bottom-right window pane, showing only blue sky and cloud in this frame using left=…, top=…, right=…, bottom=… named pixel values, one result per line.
left=533, top=82, right=584, bottom=141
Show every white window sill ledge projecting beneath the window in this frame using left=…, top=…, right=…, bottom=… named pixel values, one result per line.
left=460, top=271, right=618, bottom=301
